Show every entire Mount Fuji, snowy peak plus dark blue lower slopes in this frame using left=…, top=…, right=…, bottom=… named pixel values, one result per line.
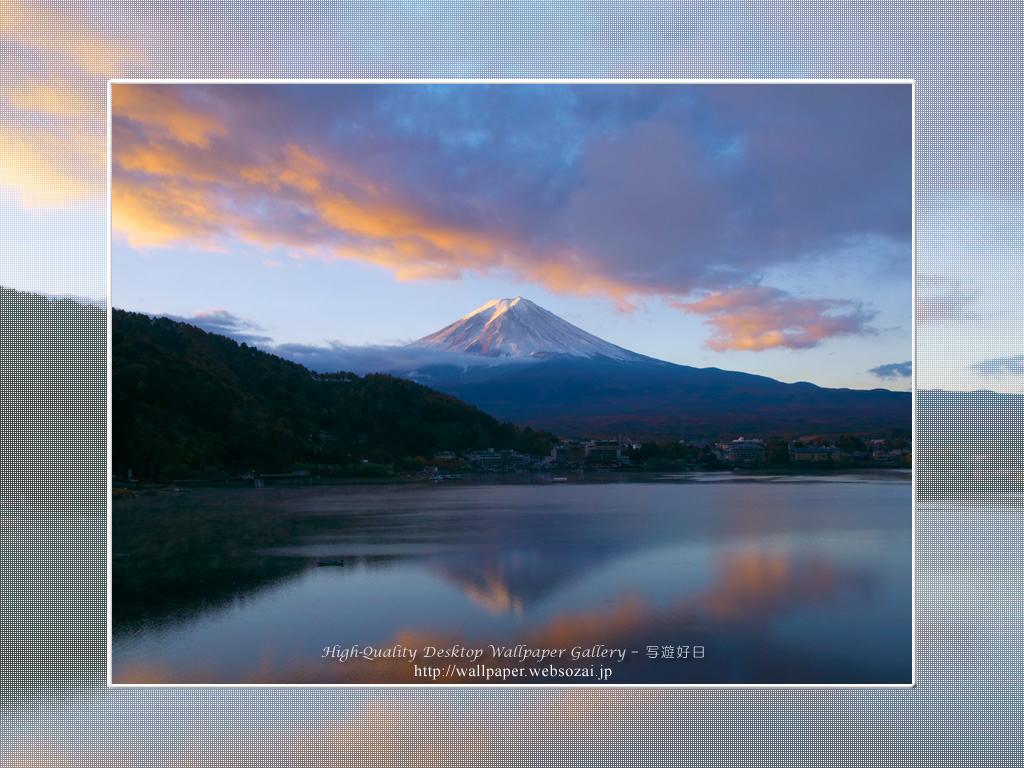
left=388, top=297, right=911, bottom=439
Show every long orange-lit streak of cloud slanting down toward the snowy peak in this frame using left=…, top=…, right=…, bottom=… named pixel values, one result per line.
left=113, top=99, right=655, bottom=308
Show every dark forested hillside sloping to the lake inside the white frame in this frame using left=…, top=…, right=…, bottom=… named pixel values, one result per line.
left=112, top=309, right=555, bottom=479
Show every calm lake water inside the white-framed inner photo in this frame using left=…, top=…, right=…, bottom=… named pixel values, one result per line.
left=112, top=471, right=913, bottom=685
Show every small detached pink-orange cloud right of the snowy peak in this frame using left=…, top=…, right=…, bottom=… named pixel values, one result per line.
left=675, top=286, right=874, bottom=352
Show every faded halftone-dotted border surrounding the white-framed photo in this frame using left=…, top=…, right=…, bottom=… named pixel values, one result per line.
left=0, top=2, right=1022, bottom=768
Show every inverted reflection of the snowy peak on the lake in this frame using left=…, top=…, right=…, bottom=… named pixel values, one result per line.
left=430, top=548, right=614, bottom=614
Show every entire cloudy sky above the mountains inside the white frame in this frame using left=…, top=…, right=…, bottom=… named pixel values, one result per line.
left=111, top=82, right=913, bottom=390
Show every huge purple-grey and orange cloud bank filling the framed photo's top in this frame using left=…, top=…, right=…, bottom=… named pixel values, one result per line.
left=112, top=85, right=911, bottom=321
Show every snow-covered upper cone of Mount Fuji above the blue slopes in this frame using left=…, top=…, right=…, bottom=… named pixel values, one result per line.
left=410, top=296, right=650, bottom=361
